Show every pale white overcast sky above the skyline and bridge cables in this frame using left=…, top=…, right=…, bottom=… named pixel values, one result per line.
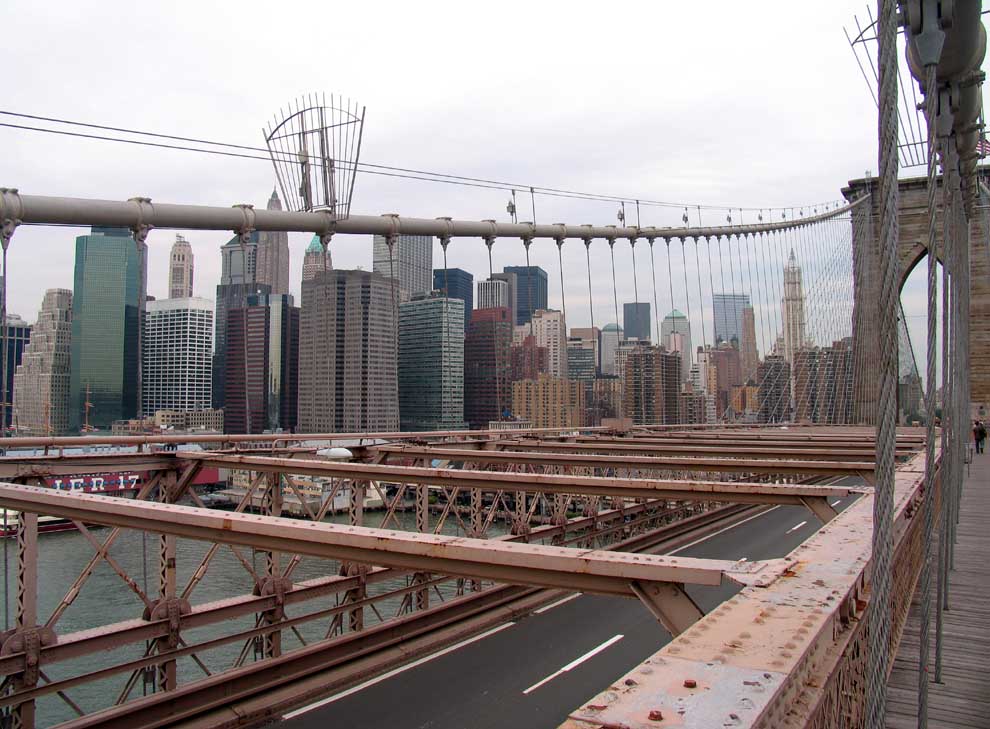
left=0, top=0, right=976, bottom=376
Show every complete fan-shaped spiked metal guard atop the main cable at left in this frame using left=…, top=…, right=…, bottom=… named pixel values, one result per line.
left=262, top=94, right=365, bottom=220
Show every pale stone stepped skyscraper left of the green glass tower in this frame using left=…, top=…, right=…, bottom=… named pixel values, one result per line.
left=13, top=289, right=72, bottom=435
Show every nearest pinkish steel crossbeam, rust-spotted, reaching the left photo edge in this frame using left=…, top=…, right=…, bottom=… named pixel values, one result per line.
left=0, top=483, right=787, bottom=596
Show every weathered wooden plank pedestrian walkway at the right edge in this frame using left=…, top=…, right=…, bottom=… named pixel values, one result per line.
left=887, top=454, right=990, bottom=729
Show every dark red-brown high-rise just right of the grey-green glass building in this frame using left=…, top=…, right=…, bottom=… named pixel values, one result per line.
left=464, top=307, right=512, bottom=428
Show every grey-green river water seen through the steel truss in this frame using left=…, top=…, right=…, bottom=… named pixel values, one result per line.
left=4, top=504, right=503, bottom=727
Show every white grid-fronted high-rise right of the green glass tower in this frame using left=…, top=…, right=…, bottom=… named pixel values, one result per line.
left=141, top=297, right=213, bottom=415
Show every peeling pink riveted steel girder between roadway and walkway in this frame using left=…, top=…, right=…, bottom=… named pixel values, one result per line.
left=562, top=454, right=924, bottom=729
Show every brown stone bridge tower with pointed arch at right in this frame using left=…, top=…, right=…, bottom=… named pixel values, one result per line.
left=842, top=177, right=990, bottom=425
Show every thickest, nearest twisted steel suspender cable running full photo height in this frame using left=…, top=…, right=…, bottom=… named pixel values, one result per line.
left=866, top=0, right=898, bottom=729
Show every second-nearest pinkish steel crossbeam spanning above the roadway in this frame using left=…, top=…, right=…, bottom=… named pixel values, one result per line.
left=177, top=451, right=863, bottom=522
